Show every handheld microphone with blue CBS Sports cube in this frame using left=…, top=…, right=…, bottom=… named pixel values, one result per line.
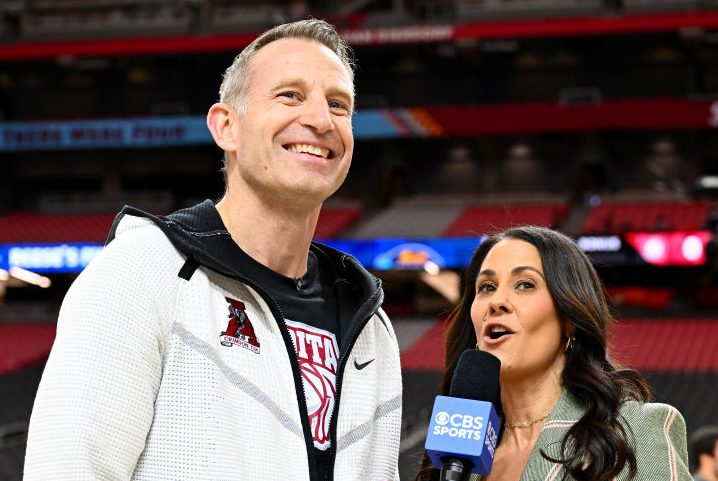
left=424, top=349, right=501, bottom=481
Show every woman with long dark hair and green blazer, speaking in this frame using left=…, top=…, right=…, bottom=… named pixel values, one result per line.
left=416, top=226, right=691, bottom=481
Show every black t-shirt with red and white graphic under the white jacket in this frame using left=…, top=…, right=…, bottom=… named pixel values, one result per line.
left=233, top=246, right=341, bottom=480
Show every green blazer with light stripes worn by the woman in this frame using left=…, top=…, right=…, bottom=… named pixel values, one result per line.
left=470, top=391, right=692, bottom=481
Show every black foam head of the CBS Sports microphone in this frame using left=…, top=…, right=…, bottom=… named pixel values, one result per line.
left=449, top=349, right=501, bottom=404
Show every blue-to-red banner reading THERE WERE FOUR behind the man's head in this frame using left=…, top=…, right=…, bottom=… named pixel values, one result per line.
left=0, top=98, right=718, bottom=152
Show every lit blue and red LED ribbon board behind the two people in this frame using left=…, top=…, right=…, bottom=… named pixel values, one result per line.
left=0, top=231, right=711, bottom=273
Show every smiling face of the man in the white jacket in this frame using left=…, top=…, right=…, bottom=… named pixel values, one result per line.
left=229, top=38, right=354, bottom=208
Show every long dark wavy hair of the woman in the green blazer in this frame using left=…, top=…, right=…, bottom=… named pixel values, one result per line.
left=416, top=226, right=651, bottom=481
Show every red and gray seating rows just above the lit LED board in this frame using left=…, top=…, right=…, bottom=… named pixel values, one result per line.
left=0, top=201, right=709, bottom=243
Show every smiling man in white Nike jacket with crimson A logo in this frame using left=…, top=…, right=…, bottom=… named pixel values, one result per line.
left=25, top=20, right=401, bottom=481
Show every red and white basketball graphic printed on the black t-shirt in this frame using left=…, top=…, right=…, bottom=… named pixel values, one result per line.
left=285, top=319, right=339, bottom=450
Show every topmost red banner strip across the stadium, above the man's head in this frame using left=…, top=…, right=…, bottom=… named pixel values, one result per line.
left=7, top=10, right=718, bottom=61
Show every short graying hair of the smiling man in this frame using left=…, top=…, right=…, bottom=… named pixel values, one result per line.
left=219, top=18, right=354, bottom=115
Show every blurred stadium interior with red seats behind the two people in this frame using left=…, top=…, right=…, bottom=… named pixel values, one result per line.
left=0, top=0, right=718, bottom=481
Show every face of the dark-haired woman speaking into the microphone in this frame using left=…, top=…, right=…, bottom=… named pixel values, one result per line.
left=471, top=239, right=564, bottom=380
